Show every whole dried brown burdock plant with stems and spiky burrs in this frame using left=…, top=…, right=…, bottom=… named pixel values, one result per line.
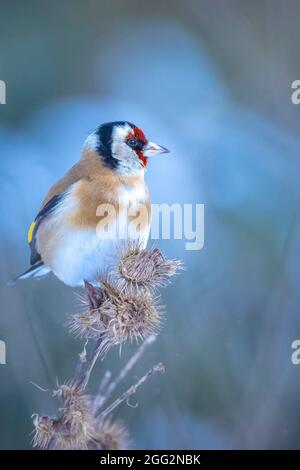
left=33, top=244, right=181, bottom=450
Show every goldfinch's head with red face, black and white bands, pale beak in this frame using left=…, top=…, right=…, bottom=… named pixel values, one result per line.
left=85, top=121, right=169, bottom=175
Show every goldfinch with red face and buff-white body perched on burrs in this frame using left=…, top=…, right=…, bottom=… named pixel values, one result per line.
left=16, top=121, right=168, bottom=286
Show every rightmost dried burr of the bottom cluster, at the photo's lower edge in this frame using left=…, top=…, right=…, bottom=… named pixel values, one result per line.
left=88, top=419, right=130, bottom=450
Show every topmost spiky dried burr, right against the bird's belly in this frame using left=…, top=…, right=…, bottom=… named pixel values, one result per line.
left=116, top=243, right=182, bottom=289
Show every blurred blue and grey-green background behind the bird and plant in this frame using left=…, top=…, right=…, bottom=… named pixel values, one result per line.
left=0, top=0, right=300, bottom=449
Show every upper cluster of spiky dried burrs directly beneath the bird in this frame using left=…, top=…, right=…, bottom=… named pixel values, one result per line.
left=68, top=246, right=182, bottom=351
